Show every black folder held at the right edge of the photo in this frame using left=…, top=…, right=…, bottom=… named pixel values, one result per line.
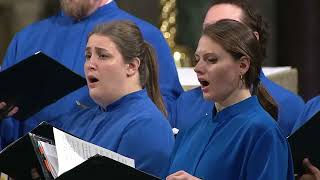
left=288, top=111, right=320, bottom=174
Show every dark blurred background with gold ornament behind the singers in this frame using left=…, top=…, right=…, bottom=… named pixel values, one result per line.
left=0, top=0, right=320, bottom=100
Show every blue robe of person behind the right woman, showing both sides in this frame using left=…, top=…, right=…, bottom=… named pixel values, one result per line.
left=170, top=71, right=305, bottom=136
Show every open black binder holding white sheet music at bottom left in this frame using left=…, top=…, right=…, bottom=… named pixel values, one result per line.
left=0, top=122, right=158, bottom=180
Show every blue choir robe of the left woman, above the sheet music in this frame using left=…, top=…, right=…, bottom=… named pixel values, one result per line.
left=52, top=90, right=174, bottom=178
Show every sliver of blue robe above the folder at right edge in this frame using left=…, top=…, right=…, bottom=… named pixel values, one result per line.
left=293, top=95, right=320, bottom=132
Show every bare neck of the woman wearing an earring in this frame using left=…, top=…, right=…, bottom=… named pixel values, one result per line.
left=215, top=89, right=251, bottom=112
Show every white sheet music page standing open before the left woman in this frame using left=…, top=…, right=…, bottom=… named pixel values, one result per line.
left=53, top=128, right=135, bottom=176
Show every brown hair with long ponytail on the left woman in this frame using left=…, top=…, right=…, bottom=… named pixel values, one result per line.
left=89, top=20, right=167, bottom=116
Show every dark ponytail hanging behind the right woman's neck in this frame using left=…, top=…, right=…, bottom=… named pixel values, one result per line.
left=256, top=82, right=278, bottom=121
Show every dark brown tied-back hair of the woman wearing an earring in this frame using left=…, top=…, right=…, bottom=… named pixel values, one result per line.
left=203, top=19, right=278, bottom=119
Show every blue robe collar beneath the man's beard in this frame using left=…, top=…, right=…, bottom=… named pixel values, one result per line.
left=60, top=1, right=119, bottom=24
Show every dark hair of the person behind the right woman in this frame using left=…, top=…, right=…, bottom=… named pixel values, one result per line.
left=207, top=0, right=269, bottom=58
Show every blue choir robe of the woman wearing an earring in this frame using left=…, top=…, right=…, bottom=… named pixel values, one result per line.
left=169, top=96, right=293, bottom=180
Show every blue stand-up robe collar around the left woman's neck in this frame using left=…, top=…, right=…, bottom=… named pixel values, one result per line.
left=99, top=89, right=148, bottom=112
